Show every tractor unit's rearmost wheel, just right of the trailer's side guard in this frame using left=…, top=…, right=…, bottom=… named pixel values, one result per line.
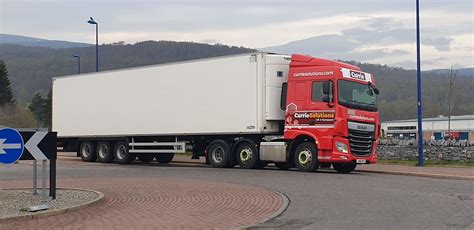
left=207, top=140, right=232, bottom=168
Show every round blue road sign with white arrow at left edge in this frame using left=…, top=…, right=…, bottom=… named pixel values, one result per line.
left=0, top=128, right=25, bottom=164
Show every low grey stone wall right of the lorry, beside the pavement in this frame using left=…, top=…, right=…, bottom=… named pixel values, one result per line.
left=377, top=139, right=474, bottom=162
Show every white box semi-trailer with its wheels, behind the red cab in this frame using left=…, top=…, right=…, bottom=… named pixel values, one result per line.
left=52, top=53, right=291, bottom=166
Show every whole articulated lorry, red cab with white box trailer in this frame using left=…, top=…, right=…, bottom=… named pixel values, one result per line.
left=52, top=53, right=380, bottom=173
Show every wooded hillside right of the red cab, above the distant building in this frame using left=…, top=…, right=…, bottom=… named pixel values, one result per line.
left=350, top=62, right=474, bottom=121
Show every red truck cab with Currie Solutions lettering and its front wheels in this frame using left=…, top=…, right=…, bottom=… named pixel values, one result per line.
left=282, top=54, right=380, bottom=173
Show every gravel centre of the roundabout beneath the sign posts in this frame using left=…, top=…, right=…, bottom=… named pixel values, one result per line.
left=0, top=189, right=99, bottom=219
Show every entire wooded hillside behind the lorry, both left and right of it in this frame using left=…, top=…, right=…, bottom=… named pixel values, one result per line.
left=0, top=41, right=474, bottom=120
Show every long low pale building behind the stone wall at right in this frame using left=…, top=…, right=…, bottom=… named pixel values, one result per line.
left=381, top=115, right=474, bottom=143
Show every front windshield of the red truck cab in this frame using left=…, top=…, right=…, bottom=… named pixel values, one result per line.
left=338, top=80, right=377, bottom=111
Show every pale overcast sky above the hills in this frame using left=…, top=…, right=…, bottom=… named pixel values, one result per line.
left=0, top=0, right=474, bottom=69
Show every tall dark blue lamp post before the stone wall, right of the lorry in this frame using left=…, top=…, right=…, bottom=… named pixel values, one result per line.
left=416, top=0, right=425, bottom=166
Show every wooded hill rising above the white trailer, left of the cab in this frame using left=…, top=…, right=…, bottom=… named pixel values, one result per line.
left=0, top=41, right=253, bottom=102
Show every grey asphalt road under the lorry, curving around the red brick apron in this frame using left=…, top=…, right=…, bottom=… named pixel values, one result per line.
left=0, top=155, right=474, bottom=229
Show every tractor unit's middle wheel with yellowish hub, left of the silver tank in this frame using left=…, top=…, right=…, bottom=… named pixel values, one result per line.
left=235, top=141, right=265, bottom=169
